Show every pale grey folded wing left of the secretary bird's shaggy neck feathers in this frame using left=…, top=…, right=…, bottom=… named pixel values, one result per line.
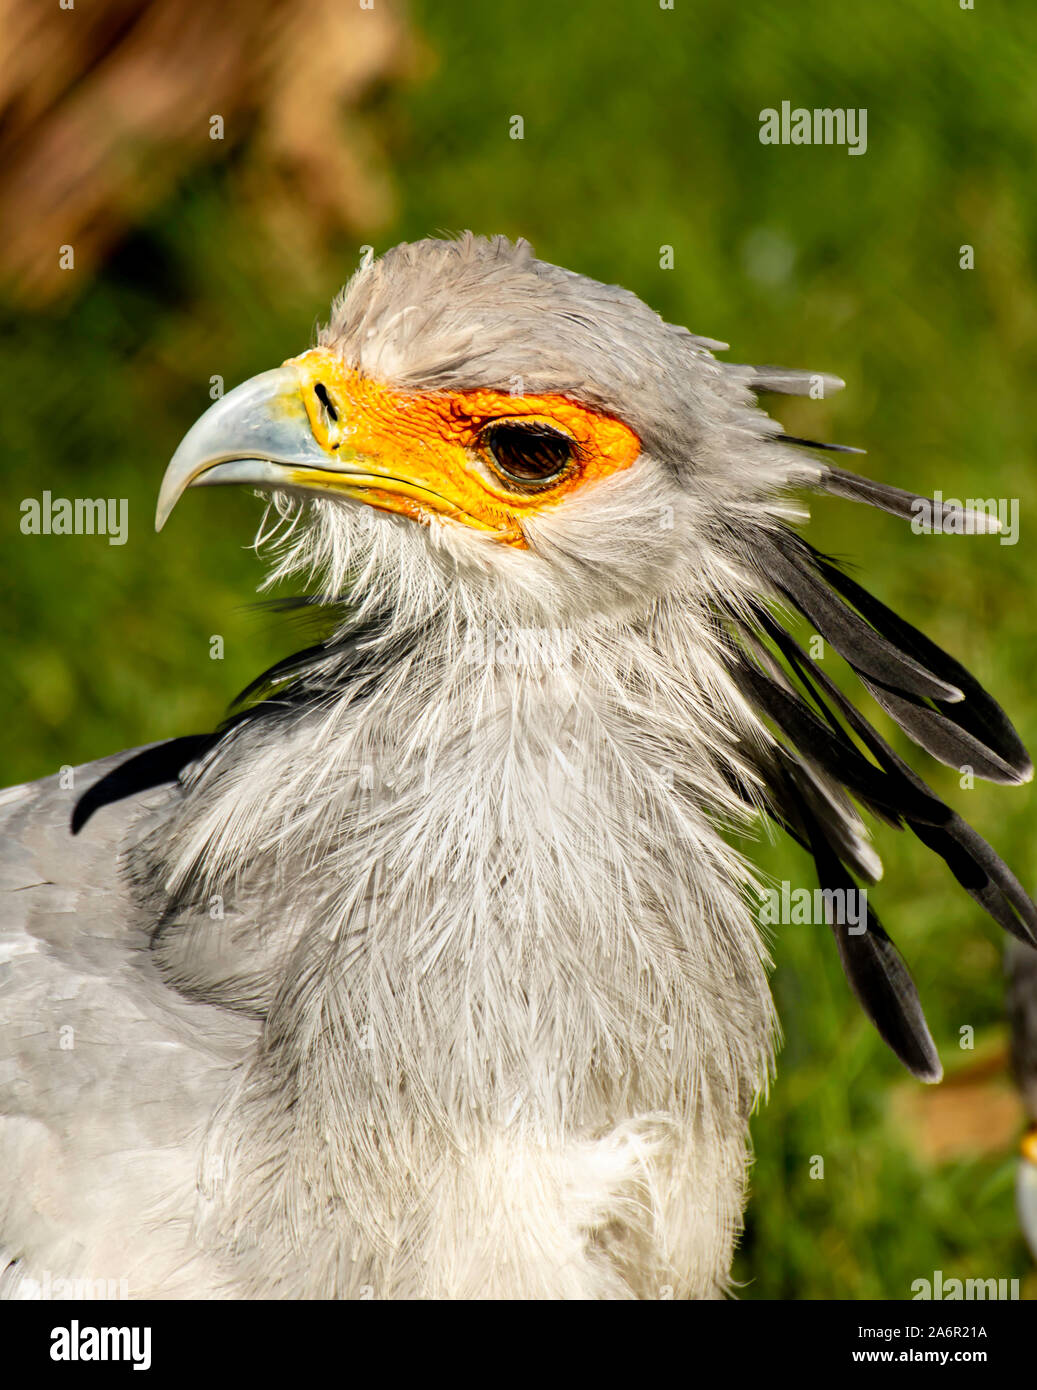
left=0, top=753, right=259, bottom=1297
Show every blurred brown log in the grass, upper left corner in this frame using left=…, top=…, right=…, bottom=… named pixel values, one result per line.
left=0, top=0, right=416, bottom=304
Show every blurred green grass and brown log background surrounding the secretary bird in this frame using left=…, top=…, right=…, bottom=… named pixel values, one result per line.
left=0, top=0, right=1037, bottom=1298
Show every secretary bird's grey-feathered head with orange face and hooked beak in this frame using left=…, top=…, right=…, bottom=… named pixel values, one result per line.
left=157, top=236, right=817, bottom=621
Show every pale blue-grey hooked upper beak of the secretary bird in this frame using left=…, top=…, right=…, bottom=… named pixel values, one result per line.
left=154, top=366, right=328, bottom=531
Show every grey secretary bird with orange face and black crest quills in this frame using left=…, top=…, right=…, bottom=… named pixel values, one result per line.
left=0, top=235, right=1037, bottom=1298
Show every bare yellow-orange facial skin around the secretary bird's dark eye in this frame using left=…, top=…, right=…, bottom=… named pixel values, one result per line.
left=285, top=348, right=641, bottom=549
